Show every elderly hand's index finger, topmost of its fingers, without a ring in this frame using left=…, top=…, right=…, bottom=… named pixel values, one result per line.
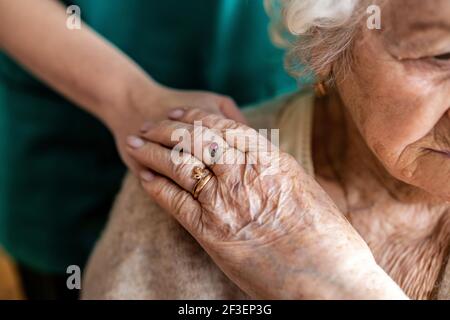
left=169, top=109, right=277, bottom=156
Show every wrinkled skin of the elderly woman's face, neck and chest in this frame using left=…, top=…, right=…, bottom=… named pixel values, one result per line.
left=320, top=0, right=450, bottom=299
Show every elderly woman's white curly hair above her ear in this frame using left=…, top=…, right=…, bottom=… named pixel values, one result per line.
left=264, top=0, right=368, bottom=81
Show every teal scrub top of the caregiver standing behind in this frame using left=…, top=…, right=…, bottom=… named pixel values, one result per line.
left=0, top=0, right=296, bottom=273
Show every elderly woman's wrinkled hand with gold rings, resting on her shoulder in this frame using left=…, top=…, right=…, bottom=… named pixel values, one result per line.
left=124, top=109, right=405, bottom=299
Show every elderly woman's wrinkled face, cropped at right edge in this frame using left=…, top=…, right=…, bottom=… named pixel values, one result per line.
left=338, top=0, right=450, bottom=200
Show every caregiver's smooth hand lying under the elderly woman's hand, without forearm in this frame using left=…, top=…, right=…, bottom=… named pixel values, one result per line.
left=102, top=81, right=246, bottom=174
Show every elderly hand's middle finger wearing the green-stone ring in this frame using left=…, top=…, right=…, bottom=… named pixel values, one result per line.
left=141, top=120, right=245, bottom=176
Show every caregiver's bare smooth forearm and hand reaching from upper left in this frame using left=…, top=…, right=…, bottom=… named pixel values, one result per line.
left=0, top=0, right=243, bottom=172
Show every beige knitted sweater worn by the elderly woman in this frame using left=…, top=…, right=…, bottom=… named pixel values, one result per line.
left=82, top=94, right=450, bottom=299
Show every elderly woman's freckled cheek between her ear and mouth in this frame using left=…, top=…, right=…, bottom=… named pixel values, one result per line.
left=338, top=51, right=445, bottom=169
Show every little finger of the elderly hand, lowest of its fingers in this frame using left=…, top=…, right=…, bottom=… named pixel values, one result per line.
left=139, top=171, right=201, bottom=232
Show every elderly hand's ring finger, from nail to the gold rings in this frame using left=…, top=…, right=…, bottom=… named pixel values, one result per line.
left=127, top=136, right=208, bottom=192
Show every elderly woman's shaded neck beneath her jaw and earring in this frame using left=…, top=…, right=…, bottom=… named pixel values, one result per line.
left=313, top=93, right=442, bottom=209
